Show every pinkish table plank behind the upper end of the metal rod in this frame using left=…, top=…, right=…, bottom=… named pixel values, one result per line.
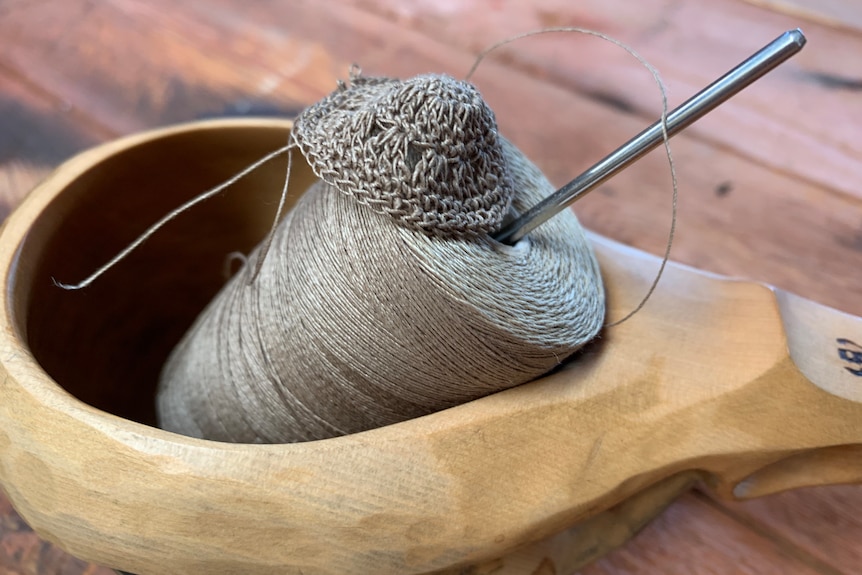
left=340, top=0, right=862, bottom=206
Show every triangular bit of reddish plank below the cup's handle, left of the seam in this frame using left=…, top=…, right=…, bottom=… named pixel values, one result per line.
left=579, top=493, right=836, bottom=575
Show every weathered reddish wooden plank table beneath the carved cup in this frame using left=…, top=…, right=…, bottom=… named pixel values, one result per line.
left=0, top=0, right=862, bottom=575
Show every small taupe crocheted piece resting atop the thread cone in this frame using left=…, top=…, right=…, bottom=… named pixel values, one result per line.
left=293, top=72, right=514, bottom=237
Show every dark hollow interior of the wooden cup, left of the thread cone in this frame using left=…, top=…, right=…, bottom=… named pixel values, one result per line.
left=9, top=122, right=314, bottom=425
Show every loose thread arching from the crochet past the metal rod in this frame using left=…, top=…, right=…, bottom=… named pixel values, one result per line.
left=464, top=26, right=679, bottom=327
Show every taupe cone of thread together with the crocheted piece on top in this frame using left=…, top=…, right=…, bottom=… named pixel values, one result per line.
left=157, top=70, right=604, bottom=443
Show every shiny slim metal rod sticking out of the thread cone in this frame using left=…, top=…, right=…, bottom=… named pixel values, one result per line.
left=494, top=29, right=805, bottom=245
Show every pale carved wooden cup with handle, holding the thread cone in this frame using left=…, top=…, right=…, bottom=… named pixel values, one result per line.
left=0, top=120, right=862, bottom=575
